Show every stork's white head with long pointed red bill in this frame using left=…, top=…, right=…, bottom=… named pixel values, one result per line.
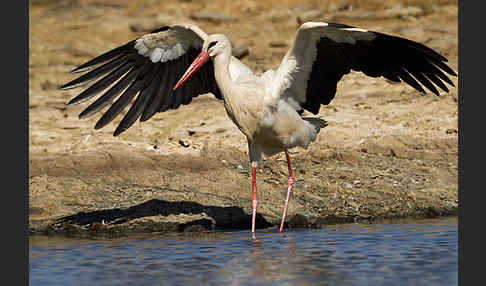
left=173, top=34, right=231, bottom=90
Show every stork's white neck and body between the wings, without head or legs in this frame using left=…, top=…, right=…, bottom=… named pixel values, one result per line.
left=214, top=49, right=323, bottom=163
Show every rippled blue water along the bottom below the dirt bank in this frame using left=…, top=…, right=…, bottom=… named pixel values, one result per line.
left=29, top=218, right=458, bottom=286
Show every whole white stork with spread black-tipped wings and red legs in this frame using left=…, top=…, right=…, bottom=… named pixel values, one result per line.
left=60, top=22, right=456, bottom=233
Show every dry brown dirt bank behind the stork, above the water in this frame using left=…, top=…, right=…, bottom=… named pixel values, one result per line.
left=29, top=0, right=458, bottom=234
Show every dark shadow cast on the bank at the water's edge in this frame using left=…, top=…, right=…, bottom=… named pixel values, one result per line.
left=42, top=199, right=273, bottom=235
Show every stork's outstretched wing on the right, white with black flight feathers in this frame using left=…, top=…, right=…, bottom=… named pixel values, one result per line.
left=271, top=22, right=457, bottom=114
